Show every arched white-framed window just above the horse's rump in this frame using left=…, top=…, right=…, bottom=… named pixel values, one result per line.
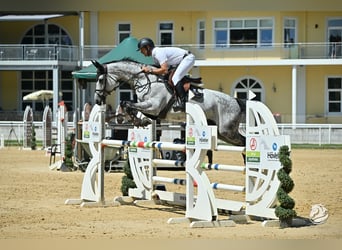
left=233, top=78, right=264, bottom=101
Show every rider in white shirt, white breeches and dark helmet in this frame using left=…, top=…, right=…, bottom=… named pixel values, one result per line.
left=137, top=38, right=195, bottom=111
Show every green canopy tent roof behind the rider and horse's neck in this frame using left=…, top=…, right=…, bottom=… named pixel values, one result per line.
left=72, top=37, right=153, bottom=79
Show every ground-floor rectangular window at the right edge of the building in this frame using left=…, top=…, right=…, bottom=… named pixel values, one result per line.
left=327, top=77, right=342, bottom=114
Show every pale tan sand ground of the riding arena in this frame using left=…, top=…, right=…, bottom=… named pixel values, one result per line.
left=0, top=148, right=342, bottom=240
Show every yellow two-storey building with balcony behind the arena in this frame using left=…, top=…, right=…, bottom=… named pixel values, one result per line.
left=0, top=0, right=342, bottom=123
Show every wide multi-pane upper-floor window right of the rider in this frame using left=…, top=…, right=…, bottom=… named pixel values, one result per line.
left=214, top=19, right=273, bottom=48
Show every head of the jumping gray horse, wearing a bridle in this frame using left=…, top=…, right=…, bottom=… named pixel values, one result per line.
left=91, top=60, right=120, bottom=105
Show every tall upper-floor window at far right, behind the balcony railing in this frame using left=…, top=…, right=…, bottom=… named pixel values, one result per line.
left=328, top=19, right=342, bottom=58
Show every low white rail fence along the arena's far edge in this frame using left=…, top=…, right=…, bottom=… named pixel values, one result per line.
left=0, top=121, right=342, bottom=145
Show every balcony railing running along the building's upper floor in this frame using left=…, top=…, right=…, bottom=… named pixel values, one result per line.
left=0, top=42, right=342, bottom=61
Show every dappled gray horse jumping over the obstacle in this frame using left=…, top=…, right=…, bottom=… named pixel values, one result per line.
left=92, top=59, right=246, bottom=146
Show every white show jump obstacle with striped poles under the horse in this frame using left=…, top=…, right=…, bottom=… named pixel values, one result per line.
left=66, top=100, right=290, bottom=227
